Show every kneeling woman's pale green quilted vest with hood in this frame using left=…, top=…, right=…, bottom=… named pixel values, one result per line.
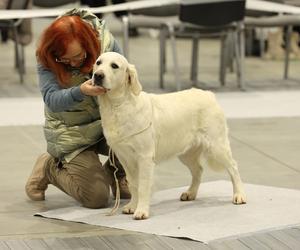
left=44, top=9, right=114, bottom=162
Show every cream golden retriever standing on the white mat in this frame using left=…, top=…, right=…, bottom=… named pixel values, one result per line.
left=93, top=52, right=246, bottom=219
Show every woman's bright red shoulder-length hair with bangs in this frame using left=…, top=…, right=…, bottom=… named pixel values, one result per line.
left=36, top=16, right=101, bottom=87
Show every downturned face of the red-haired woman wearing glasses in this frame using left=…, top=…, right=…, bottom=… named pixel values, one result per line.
left=56, top=40, right=86, bottom=68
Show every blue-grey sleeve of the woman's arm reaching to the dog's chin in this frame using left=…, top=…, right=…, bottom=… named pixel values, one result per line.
left=37, top=64, right=84, bottom=112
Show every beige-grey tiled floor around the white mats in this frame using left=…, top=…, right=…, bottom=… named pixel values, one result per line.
left=0, top=4, right=300, bottom=249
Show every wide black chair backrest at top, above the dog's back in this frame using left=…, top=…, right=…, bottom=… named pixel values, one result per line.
left=179, top=0, right=246, bottom=26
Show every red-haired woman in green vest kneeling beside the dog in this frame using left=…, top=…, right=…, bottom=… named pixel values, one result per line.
left=25, top=9, right=130, bottom=208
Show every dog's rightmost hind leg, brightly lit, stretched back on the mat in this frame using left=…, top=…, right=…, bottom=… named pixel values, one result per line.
left=202, top=142, right=246, bottom=204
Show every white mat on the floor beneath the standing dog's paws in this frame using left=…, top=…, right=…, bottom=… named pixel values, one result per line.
left=36, top=181, right=300, bottom=242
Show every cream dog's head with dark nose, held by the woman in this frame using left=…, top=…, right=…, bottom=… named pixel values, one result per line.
left=93, top=52, right=142, bottom=95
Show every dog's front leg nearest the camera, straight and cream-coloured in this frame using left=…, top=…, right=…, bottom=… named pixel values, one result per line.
left=133, top=158, right=155, bottom=220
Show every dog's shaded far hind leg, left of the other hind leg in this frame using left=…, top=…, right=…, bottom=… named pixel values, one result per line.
left=178, top=149, right=203, bottom=201
